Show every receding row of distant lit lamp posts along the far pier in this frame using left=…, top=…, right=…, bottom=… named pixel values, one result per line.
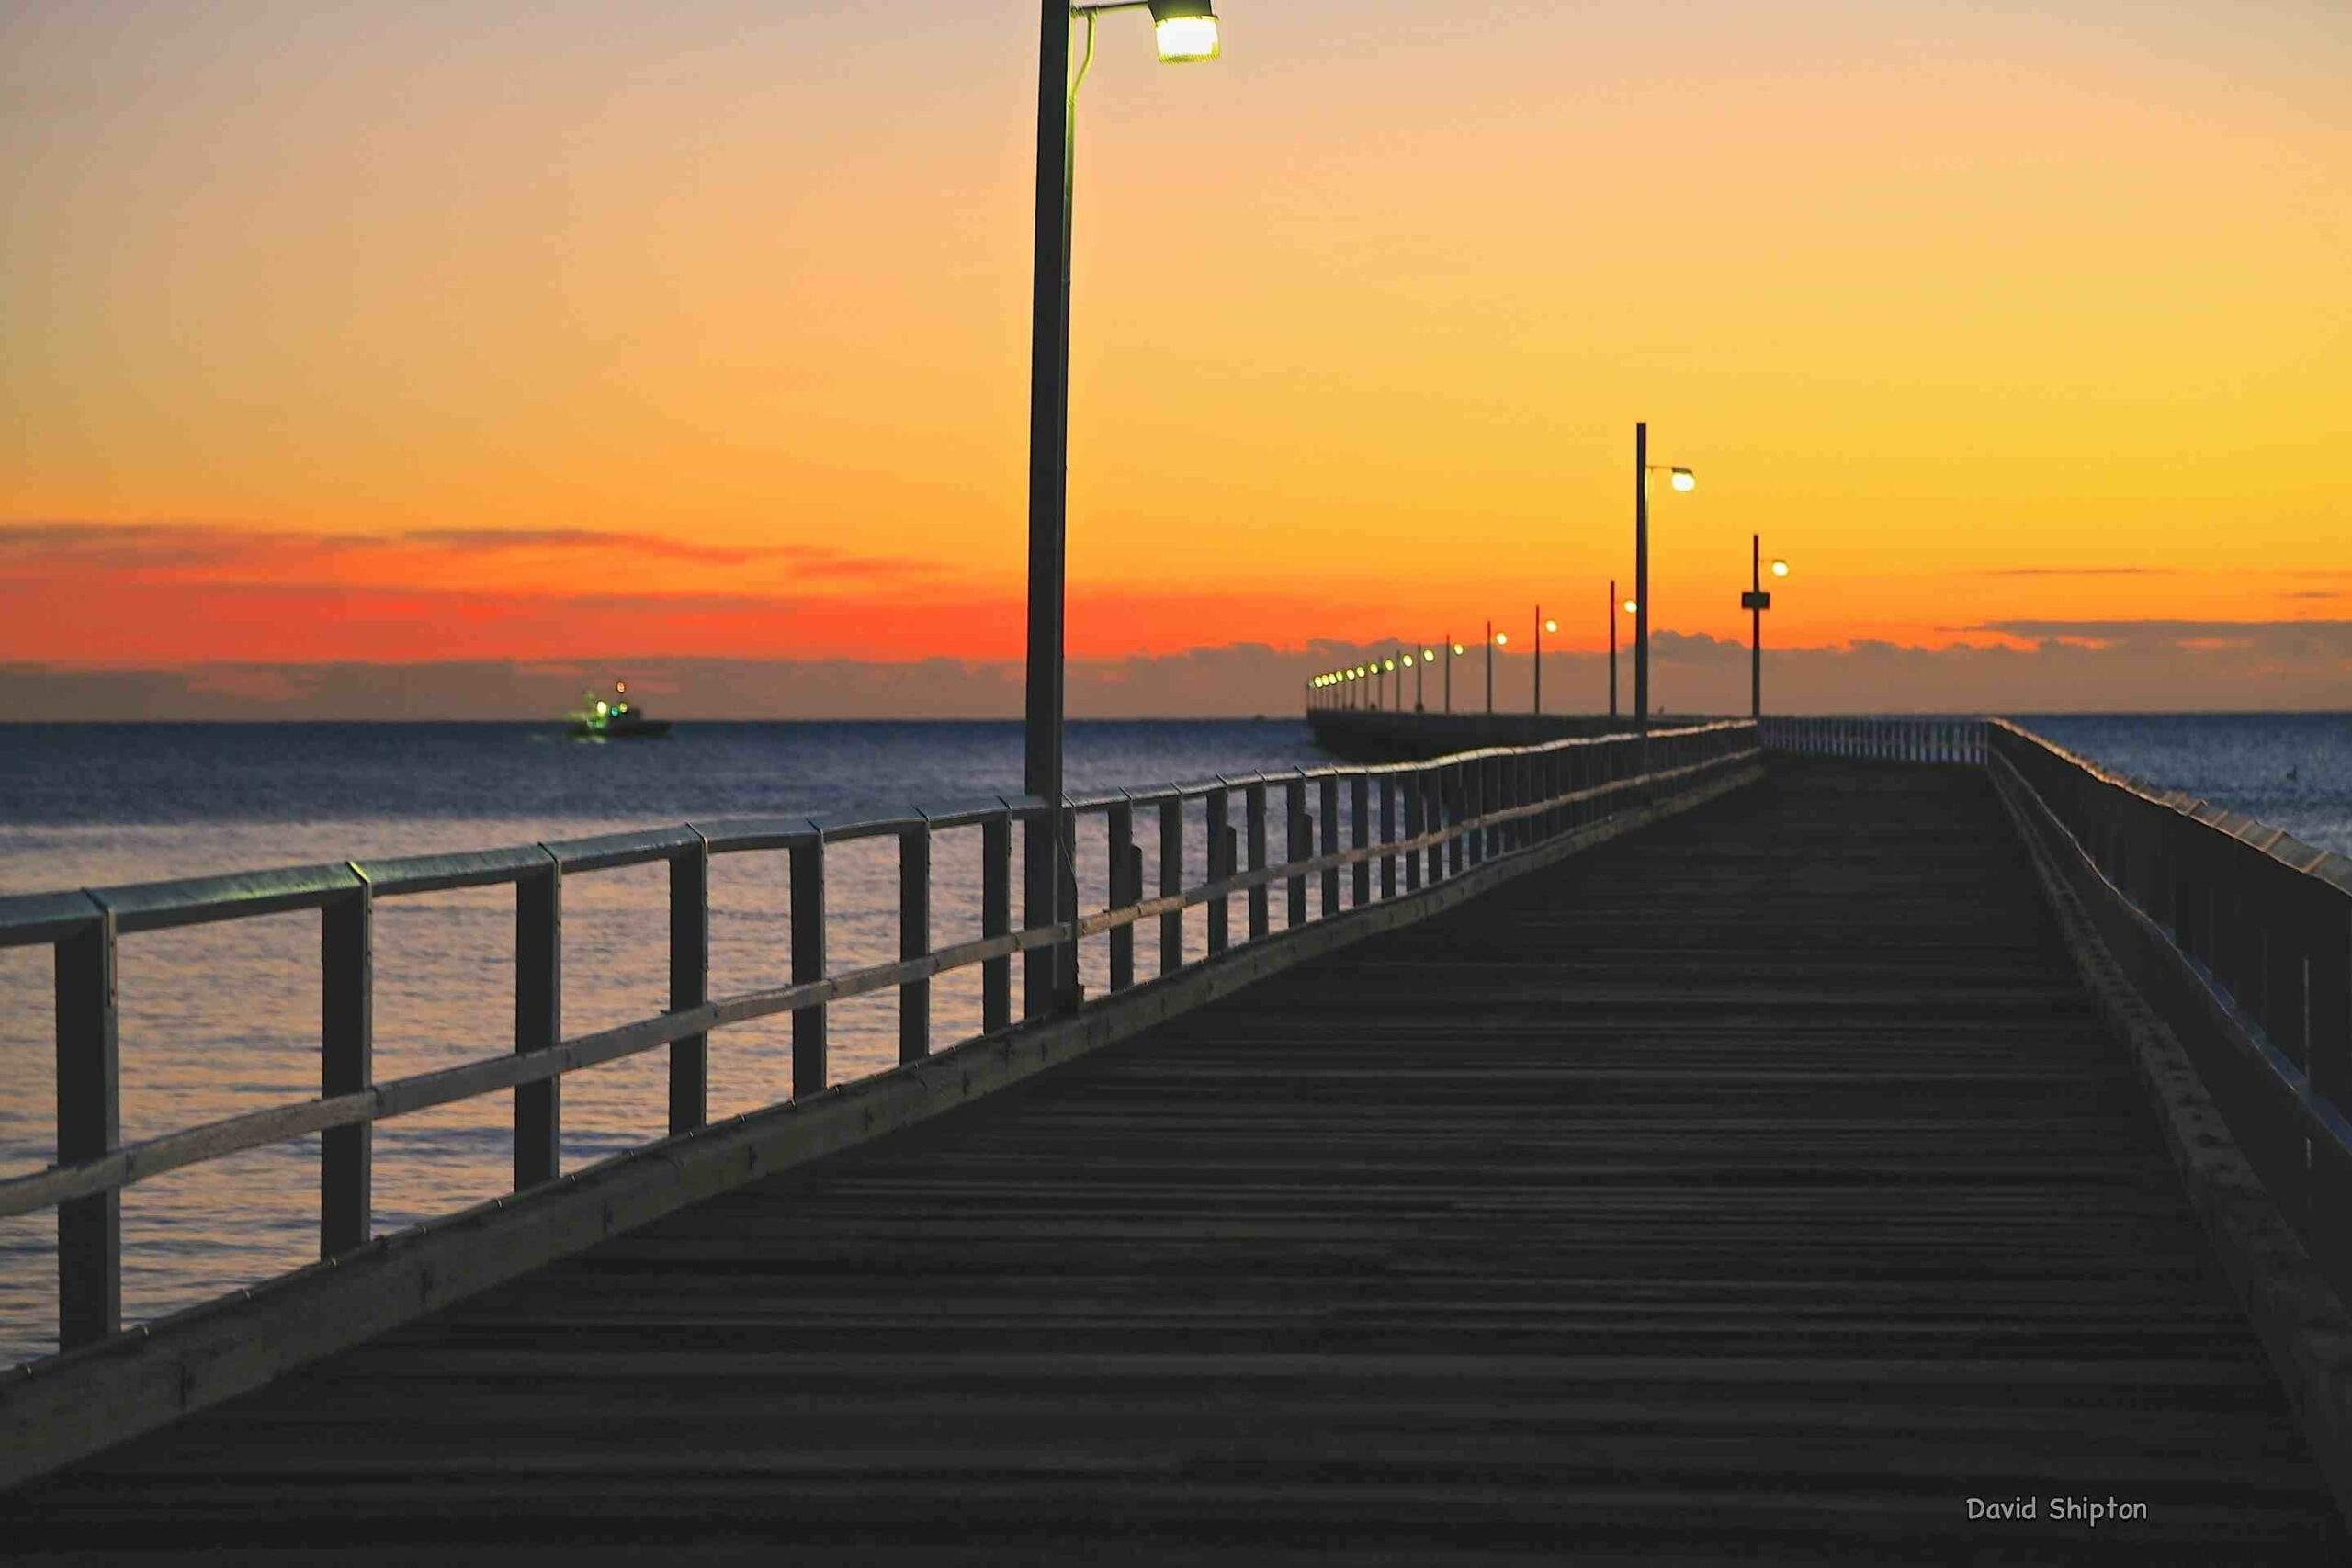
left=1306, top=434, right=1788, bottom=733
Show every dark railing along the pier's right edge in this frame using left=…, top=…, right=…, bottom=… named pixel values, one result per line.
left=1990, top=719, right=2352, bottom=1288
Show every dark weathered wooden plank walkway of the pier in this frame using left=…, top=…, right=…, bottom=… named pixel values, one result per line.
left=7, top=764, right=2345, bottom=1563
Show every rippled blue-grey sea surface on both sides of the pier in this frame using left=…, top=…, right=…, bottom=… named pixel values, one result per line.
left=0, top=715, right=2352, bottom=1361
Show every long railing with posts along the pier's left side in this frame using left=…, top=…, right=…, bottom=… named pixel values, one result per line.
left=0, top=722, right=1757, bottom=1349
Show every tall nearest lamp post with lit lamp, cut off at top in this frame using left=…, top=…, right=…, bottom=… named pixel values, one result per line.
left=1021, top=0, right=1218, bottom=1018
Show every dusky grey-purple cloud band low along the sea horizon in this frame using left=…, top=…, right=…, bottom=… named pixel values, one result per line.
left=0, top=621, right=2352, bottom=722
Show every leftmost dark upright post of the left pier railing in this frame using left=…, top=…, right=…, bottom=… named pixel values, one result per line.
left=56, top=908, right=122, bottom=1349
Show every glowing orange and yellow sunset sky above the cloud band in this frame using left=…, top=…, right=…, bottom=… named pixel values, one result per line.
left=0, top=0, right=2352, bottom=695
